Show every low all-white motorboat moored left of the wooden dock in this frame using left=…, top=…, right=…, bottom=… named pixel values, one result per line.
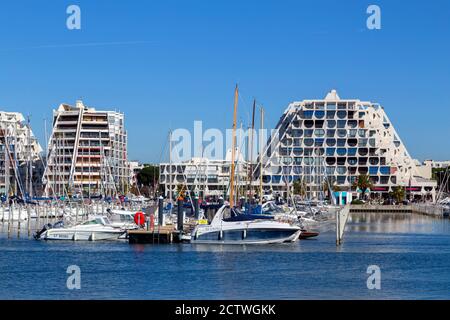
left=35, top=216, right=126, bottom=241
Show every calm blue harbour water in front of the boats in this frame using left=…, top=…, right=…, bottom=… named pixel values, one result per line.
left=0, top=214, right=450, bottom=300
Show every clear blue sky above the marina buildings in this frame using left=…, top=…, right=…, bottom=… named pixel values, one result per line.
left=0, top=0, right=450, bottom=162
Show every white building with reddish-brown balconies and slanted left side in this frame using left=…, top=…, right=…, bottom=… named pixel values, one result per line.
left=43, top=101, right=131, bottom=196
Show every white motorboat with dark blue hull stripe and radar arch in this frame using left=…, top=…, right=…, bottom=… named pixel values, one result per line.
left=191, top=205, right=301, bottom=244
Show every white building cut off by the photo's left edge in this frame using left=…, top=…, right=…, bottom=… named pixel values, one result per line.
left=0, top=111, right=43, bottom=198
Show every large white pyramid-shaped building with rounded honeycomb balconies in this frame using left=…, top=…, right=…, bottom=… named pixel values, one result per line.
left=255, top=90, right=436, bottom=198
